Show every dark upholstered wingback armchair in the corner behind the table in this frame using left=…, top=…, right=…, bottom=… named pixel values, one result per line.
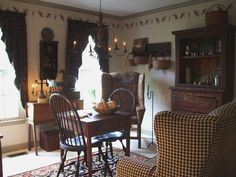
left=101, top=72, right=146, bottom=148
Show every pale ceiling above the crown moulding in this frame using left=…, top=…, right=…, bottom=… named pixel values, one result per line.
left=38, top=0, right=209, bottom=18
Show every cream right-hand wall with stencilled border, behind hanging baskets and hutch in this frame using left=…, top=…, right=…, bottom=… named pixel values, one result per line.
left=111, top=0, right=236, bottom=134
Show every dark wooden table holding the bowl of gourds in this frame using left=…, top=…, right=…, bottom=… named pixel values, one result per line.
left=81, top=113, right=131, bottom=177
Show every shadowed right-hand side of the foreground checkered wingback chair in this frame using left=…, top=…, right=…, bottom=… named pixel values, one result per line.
left=204, top=100, right=236, bottom=177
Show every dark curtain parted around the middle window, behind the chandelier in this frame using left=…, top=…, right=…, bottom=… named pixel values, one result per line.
left=65, top=19, right=109, bottom=77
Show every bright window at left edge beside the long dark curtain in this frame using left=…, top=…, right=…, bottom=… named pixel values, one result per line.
left=0, top=29, right=22, bottom=121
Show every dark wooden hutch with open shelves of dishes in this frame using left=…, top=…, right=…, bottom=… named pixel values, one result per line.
left=170, top=25, right=236, bottom=114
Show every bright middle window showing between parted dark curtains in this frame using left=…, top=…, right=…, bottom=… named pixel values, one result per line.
left=76, top=36, right=101, bottom=109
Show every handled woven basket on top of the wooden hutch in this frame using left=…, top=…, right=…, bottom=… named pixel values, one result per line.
left=205, top=4, right=228, bottom=26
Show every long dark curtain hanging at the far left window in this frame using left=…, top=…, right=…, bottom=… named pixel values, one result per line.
left=0, top=10, right=28, bottom=108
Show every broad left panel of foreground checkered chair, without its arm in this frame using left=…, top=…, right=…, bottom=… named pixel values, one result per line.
left=155, top=111, right=220, bottom=177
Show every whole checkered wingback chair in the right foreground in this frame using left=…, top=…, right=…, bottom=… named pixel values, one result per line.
left=117, top=101, right=236, bottom=177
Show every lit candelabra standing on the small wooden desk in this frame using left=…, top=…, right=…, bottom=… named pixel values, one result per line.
left=31, top=80, right=48, bottom=102
